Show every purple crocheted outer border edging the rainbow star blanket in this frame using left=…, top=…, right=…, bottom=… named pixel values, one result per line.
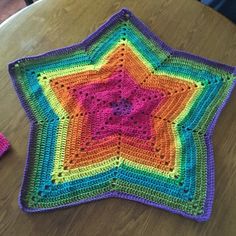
left=8, top=8, right=236, bottom=222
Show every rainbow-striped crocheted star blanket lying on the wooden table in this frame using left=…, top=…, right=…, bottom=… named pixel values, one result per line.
left=9, top=9, right=236, bottom=221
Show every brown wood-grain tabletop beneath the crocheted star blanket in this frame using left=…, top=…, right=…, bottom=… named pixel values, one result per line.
left=0, top=0, right=236, bottom=236
